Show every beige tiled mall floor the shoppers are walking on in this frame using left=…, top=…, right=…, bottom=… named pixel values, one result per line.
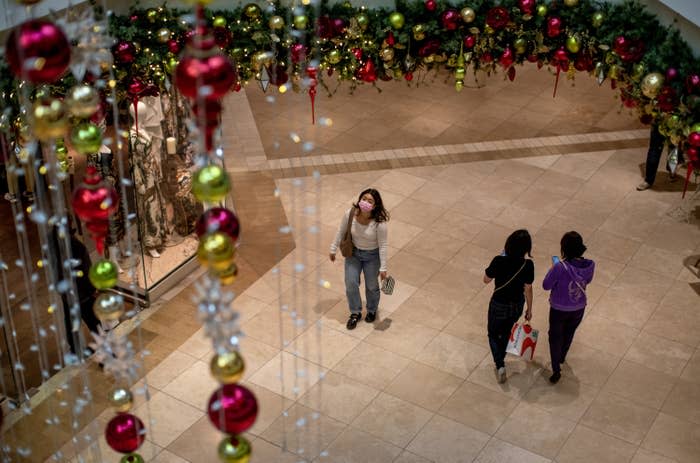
left=5, top=66, right=700, bottom=463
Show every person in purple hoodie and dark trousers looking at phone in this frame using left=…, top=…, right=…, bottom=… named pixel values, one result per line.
left=542, top=231, right=595, bottom=384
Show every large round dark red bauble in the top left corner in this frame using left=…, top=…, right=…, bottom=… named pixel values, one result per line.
left=5, top=19, right=70, bottom=84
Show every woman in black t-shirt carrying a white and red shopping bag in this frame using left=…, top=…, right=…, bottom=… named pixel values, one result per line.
left=484, top=230, right=535, bottom=383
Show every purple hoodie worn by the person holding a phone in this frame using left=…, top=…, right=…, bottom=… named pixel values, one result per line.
left=542, top=259, right=595, bottom=312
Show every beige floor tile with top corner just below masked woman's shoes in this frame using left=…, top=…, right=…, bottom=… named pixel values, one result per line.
left=333, top=342, right=410, bottom=390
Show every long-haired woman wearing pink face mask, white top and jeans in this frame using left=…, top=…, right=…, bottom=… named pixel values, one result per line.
left=330, top=188, right=389, bottom=330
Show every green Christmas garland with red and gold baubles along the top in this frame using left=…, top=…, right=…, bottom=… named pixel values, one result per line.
left=0, top=0, right=700, bottom=161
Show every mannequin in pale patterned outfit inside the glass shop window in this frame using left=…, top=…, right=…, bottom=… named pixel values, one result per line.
left=129, top=97, right=167, bottom=257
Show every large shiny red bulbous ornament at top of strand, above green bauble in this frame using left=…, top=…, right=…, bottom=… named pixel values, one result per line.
left=175, top=50, right=236, bottom=100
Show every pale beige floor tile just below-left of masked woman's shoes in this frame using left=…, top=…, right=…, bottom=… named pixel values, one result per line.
left=285, top=326, right=360, bottom=368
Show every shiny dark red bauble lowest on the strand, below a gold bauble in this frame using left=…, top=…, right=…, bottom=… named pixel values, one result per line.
left=207, top=384, right=258, bottom=434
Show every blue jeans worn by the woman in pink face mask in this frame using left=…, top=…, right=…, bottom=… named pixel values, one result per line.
left=345, top=248, right=380, bottom=314
